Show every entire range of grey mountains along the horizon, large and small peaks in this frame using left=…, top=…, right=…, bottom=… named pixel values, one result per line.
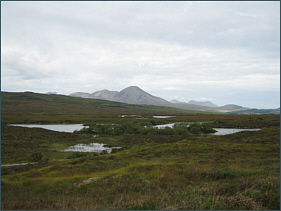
left=70, top=86, right=280, bottom=113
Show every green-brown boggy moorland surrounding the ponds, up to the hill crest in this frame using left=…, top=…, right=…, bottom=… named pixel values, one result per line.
left=1, top=93, right=280, bottom=210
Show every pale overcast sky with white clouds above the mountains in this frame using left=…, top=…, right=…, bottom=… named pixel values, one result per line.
left=1, top=1, right=280, bottom=108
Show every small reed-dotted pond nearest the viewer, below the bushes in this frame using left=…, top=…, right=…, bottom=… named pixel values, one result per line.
left=61, top=143, right=121, bottom=153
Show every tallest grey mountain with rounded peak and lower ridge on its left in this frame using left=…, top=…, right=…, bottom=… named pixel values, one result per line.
left=70, top=86, right=170, bottom=106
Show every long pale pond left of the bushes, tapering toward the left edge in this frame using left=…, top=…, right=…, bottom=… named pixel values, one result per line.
left=8, top=124, right=88, bottom=133
